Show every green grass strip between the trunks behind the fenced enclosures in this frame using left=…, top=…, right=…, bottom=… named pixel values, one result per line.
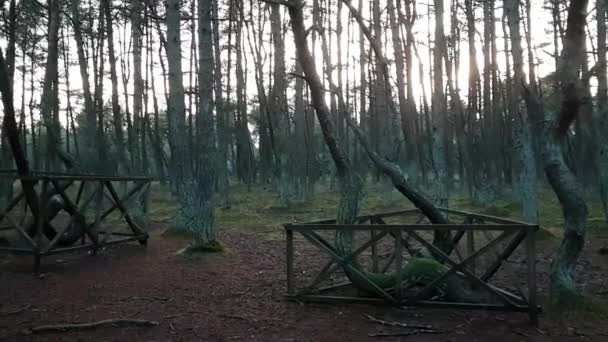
left=149, top=179, right=608, bottom=239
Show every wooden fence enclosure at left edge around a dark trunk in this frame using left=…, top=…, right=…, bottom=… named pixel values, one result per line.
left=0, top=172, right=152, bottom=270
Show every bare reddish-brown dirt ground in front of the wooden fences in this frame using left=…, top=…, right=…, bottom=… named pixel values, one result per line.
left=0, top=227, right=608, bottom=342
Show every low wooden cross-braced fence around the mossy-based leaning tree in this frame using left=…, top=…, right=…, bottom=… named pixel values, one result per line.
left=284, top=209, right=540, bottom=323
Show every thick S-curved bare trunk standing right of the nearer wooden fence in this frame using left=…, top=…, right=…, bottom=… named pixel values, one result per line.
left=548, top=0, right=588, bottom=304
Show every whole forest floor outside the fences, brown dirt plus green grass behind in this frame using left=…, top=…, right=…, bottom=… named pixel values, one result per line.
left=0, top=183, right=608, bottom=342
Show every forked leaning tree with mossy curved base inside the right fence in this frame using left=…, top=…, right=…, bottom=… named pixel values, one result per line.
left=262, top=0, right=478, bottom=301
